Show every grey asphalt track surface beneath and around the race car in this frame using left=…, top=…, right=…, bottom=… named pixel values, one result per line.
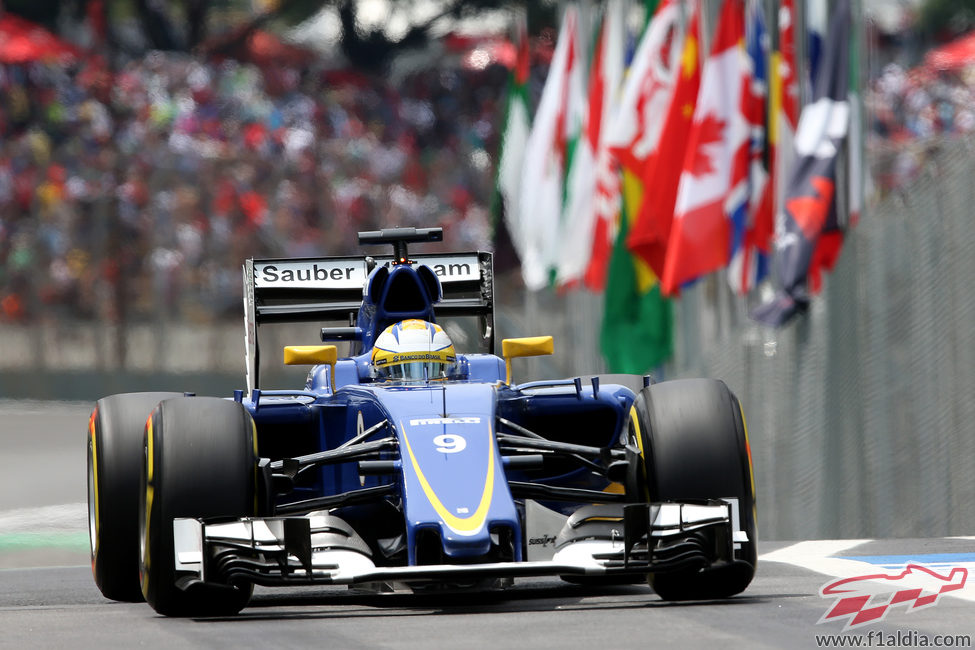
left=0, top=402, right=975, bottom=650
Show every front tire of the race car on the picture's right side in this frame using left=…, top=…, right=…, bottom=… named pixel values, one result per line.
left=633, top=379, right=758, bottom=600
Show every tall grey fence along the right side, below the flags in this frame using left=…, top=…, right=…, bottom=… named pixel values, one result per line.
left=508, top=134, right=975, bottom=539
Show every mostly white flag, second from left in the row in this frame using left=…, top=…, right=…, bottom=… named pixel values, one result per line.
left=511, top=4, right=585, bottom=290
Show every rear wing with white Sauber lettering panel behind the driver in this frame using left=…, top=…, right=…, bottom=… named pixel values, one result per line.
left=244, top=251, right=494, bottom=392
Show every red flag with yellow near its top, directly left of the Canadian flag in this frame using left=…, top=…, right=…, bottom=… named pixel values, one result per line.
left=627, top=2, right=701, bottom=277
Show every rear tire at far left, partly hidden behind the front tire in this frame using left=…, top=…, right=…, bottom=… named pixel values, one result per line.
left=88, top=393, right=182, bottom=602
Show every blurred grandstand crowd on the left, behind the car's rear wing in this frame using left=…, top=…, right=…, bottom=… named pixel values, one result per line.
left=0, top=52, right=507, bottom=322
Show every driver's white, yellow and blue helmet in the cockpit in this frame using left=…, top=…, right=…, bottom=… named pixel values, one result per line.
left=372, top=318, right=457, bottom=381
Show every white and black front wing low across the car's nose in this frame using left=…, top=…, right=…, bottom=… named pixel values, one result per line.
left=173, top=501, right=749, bottom=588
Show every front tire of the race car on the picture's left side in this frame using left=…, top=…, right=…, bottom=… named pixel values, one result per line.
left=139, top=397, right=257, bottom=616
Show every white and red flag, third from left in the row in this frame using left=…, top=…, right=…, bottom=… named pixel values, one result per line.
left=556, top=0, right=624, bottom=289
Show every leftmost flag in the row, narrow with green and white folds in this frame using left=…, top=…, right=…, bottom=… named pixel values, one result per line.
left=493, top=10, right=531, bottom=269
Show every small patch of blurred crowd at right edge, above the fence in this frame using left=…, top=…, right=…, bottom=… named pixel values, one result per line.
left=865, top=63, right=975, bottom=192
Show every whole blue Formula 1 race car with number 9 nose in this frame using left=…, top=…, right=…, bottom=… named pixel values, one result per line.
left=88, top=228, right=757, bottom=616
